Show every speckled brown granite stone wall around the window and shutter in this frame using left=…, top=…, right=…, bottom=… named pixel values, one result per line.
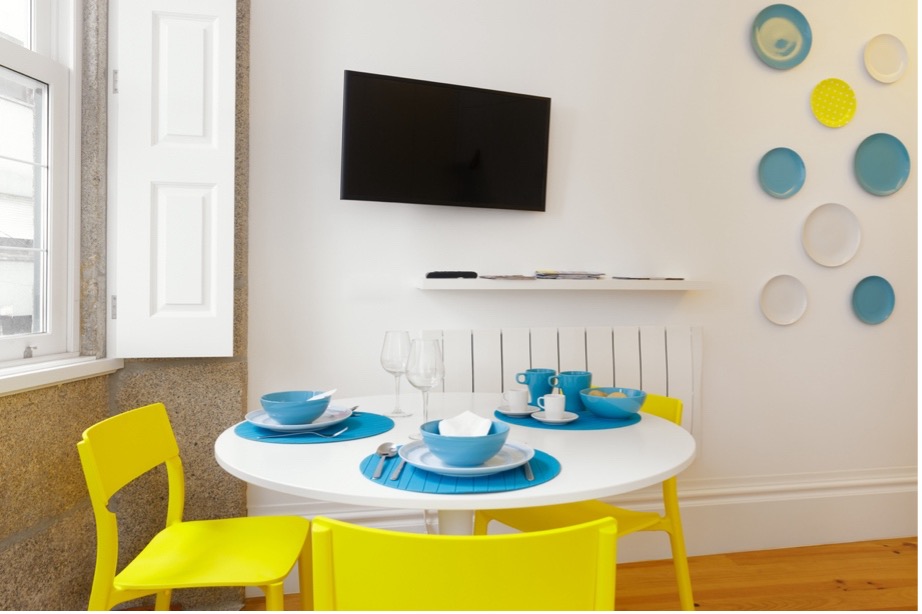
left=0, top=0, right=249, bottom=610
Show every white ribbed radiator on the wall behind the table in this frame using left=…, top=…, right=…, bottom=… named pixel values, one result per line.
left=423, top=326, right=701, bottom=432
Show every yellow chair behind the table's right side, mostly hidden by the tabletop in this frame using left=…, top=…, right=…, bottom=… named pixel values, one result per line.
left=474, top=394, right=695, bottom=610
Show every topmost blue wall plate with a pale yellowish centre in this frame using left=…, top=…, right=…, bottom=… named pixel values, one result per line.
left=752, top=4, right=813, bottom=70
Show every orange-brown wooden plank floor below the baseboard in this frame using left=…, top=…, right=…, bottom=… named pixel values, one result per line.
left=243, top=537, right=918, bottom=610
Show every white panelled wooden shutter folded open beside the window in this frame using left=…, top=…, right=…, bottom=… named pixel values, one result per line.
left=108, top=0, right=236, bottom=357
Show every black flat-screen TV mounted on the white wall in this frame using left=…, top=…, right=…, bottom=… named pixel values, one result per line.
left=340, top=70, right=551, bottom=211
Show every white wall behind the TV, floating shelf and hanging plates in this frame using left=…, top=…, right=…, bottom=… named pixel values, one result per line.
left=249, top=0, right=919, bottom=552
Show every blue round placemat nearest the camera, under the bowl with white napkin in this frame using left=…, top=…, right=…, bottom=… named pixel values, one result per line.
left=362, top=448, right=560, bottom=495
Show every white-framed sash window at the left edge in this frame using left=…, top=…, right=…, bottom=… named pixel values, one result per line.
left=0, top=0, right=76, bottom=364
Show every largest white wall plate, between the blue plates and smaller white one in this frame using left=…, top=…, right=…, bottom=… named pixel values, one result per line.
left=802, top=203, right=861, bottom=267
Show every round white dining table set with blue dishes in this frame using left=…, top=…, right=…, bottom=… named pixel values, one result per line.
left=215, top=393, right=695, bottom=534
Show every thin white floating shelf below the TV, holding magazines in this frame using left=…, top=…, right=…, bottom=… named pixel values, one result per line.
left=416, top=278, right=710, bottom=292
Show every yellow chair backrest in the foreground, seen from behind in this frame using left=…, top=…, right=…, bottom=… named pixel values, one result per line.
left=311, top=517, right=617, bottom=610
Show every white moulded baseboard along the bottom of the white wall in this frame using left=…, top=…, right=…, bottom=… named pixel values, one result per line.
left=241, top=467, right=918, bottom=596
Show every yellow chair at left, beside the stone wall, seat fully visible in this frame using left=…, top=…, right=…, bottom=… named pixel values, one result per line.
left=77, top=403, right=311, bottom=610
